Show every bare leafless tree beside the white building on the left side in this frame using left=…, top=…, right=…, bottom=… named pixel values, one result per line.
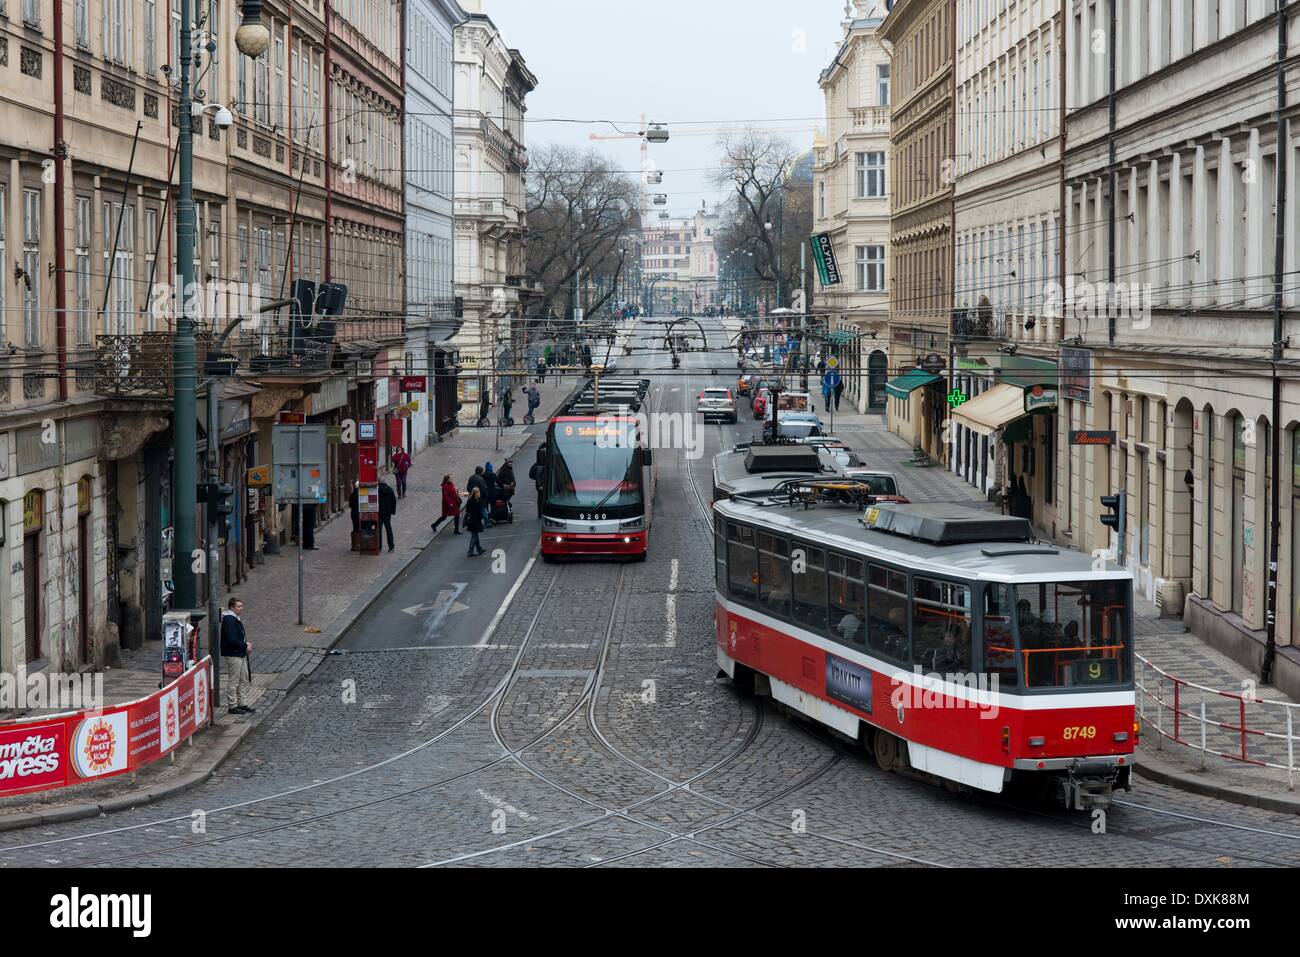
left=528, top=144, right=640, bottom=329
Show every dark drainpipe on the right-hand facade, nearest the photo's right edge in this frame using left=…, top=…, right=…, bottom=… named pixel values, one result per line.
left=1260, top=4, right=1284, bottom=684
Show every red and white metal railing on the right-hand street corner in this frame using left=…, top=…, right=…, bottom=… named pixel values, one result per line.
left=1136, top=655, right=1300, bottom=789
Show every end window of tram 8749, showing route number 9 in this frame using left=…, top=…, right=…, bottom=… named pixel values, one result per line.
left=1009, top=580, right=1132, bottom=689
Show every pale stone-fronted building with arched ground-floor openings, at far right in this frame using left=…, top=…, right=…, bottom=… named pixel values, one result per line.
left=1056, top=0, right=1300, bottom=694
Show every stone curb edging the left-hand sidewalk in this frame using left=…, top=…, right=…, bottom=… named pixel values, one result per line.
left=0, top=433, right=548, bottom=833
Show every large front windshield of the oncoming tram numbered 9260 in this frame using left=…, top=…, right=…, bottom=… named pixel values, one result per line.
left=546, top=421, right=642, bottom=508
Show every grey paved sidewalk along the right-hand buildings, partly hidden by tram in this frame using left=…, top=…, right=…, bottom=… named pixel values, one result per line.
left=818, top=402, right=1300, bottom=814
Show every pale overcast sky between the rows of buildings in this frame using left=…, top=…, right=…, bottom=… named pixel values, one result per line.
left=482, top=0, right=870, bottom=217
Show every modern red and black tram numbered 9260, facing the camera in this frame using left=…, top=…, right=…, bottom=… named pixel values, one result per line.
left=538, top=377, right=655, bottom=562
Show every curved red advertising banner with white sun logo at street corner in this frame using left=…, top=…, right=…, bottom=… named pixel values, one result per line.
left=0, top=658, right=212, bottom=796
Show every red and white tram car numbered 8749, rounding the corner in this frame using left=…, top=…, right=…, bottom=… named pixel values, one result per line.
left=714, top=482, right=1138, bottom=810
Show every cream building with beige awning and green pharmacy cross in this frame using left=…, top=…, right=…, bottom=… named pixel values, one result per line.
left=948, top=0, right=1070, bottom=536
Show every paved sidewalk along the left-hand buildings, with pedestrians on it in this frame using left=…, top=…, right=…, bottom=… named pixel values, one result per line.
left=0, top=376, right=576, bottom=831
